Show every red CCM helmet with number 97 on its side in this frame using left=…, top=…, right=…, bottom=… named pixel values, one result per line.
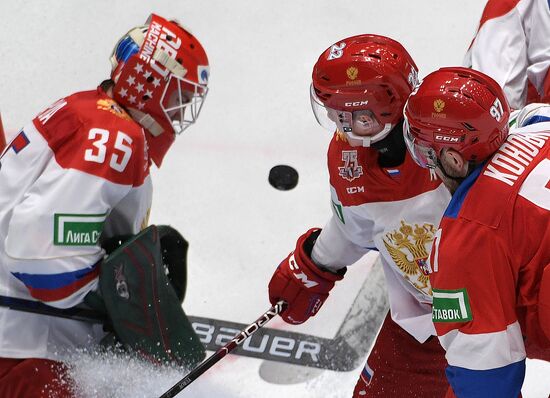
left=404, top=67, right=510, bottom=168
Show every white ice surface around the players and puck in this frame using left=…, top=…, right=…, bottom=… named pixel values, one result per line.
left=0, top=0, right=550, bottom=398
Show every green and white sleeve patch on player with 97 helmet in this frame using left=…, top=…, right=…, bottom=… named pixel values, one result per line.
left=432, top=289, right=473, bottom=322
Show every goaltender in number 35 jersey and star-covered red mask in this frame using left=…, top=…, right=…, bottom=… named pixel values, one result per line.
left=0, top=15, right=209, bottom=398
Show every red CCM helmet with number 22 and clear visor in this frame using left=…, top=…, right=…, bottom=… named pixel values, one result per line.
left=310, top=34, right=418, bottom=146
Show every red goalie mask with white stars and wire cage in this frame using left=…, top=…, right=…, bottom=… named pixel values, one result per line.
left=111, top=14, right=209, bottom=166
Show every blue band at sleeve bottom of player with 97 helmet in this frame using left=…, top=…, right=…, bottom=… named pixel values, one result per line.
left=445, top=360, right=525, bottom=398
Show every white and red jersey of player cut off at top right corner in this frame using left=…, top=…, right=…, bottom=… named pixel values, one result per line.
left=464, top=0, right=550, bottom=109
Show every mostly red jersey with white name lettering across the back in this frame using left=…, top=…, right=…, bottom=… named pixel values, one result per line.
left=429, top=106, right=550, bottom=398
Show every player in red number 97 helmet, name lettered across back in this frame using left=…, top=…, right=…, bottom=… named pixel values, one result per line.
left=405, top=67, right=550, bottom=398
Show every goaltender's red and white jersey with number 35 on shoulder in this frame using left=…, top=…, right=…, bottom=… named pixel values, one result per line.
left=0, top=89, right=152, bottom=359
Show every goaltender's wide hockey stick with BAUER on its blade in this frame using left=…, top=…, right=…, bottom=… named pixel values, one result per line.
left=0, top=258, right=389, bottom=374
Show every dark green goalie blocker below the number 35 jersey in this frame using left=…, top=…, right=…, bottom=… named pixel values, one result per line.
left=85, top=225, right=205, bottom=367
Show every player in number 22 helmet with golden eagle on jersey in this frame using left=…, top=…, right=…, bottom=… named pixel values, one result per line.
left=269, top=34, right=458, bottom=398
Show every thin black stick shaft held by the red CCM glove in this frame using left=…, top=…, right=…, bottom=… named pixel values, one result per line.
left=160, top=301, right=286, bottom=398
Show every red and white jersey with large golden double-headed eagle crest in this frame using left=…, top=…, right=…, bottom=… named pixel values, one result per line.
left=312, top=133, right=450, bottom=342
